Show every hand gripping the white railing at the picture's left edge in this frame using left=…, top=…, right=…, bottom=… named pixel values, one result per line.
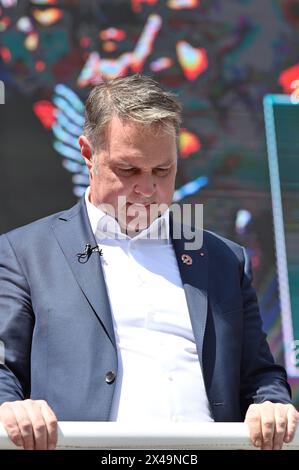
left=0, top=400, right=57, bottom=450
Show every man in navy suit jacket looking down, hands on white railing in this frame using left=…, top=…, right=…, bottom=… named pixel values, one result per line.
left=0, top=72, right=298, bottom=449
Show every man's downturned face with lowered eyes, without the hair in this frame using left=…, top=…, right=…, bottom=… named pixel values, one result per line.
left=81, top=116, right=177, bottom=231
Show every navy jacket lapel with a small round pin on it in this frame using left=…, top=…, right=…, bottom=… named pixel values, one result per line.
left=170, top=219, right=208, bottom=370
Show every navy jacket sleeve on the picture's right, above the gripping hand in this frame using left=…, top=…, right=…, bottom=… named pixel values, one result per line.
left=240, top=248, right=291, bottom=415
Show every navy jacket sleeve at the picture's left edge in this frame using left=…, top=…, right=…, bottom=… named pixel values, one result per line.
left=0, top=235, right=34, bottom=404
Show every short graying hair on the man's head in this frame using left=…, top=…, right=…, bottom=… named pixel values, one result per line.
left=83, top=74, right=181, bottom=149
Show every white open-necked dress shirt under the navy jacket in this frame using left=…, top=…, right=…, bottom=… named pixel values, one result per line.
left=85, top=189, right=213, bottom=423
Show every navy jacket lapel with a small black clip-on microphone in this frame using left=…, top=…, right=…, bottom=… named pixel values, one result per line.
left=53, top=199, right=115, bottom=345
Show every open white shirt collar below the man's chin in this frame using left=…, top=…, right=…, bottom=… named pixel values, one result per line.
left=85, top=187, right=169, bottom=242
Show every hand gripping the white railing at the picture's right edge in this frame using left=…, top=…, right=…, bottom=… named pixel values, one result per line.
left=245, top=401, right=299, bottom=450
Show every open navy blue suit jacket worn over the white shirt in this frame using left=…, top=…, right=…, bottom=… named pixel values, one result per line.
left=0, top=200, right=290, bottom=421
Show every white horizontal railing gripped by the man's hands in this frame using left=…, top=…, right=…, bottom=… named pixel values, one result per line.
left=0, top=421, right=299, bottom=450
